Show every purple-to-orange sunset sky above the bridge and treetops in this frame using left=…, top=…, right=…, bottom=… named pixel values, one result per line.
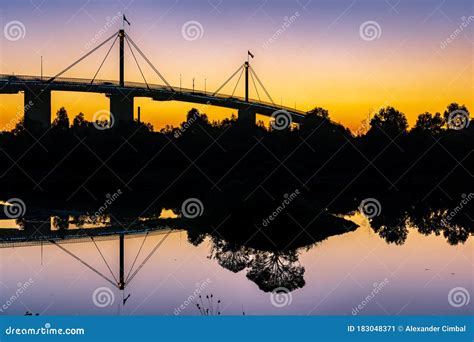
left=0, top=0, right=474, bottom=130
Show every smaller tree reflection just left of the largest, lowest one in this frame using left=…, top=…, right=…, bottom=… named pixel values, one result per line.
left=210, top=239, right=250, bottom=273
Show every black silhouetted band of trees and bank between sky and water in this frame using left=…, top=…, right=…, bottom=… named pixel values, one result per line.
left=0, top=103, right=468, bottom=196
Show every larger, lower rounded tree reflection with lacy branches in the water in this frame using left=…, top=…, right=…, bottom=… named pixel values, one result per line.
left=247, top=251, right=305, bottom=292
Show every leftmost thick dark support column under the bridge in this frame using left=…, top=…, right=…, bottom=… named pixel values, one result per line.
left=23, top=89, right=51, bottom=130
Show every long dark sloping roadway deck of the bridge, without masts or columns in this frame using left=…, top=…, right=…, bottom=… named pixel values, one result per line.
left=0, top=74, right=306, bottom=114
